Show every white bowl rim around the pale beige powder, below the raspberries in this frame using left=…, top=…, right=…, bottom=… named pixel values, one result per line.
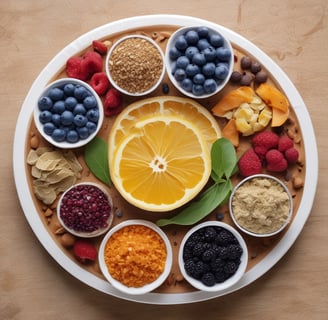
left=229, top=174, right=293, bottom=237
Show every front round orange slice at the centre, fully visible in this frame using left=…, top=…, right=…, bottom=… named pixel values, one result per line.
left=111, top=115, right=211, bottom=211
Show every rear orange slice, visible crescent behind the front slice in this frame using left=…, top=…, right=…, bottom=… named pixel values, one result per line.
left=109, top=96, right=221, bottom=163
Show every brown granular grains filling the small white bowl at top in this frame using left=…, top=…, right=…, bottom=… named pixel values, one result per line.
left=108, top=37, right=163, bottom=94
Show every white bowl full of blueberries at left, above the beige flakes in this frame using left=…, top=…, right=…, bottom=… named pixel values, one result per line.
left=34, top=78, right=104, bottom=149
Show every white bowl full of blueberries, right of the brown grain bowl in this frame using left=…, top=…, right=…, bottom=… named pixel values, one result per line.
left=165, top=26, right=234, bottom=98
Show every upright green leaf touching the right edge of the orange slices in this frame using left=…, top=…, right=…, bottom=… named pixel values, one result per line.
left=211, top=138, right=237, bottom=182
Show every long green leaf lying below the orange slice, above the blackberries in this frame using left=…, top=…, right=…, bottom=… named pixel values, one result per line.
left=156, top=180, right=233, bottom=227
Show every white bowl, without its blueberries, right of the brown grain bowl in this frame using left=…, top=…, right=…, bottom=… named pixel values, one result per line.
left=165, top=26, right=234, bottom=99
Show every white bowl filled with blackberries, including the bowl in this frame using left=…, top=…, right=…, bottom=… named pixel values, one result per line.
left=178, top=221, right=248, bottom=292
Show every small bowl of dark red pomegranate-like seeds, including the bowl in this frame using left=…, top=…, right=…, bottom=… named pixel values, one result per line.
left=57, top=182, right=114, bottom=238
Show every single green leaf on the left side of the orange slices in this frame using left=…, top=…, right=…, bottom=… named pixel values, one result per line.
left=84, top=137, right=112, bottom=186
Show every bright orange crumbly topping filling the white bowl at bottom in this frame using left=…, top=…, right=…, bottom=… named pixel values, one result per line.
left=104, top=225, right=167, bottom=288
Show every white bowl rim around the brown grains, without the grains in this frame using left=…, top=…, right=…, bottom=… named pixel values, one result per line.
left=105, top=35, right=165, bottom=97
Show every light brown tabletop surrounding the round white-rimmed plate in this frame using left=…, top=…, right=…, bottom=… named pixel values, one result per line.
left=0, top=0, right=328, bottom=320
